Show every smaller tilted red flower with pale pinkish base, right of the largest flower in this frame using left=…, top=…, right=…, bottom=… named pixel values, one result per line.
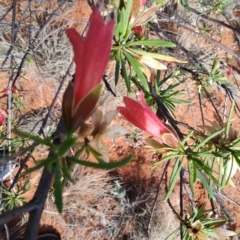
left=117, top=92, right=179, bottom=147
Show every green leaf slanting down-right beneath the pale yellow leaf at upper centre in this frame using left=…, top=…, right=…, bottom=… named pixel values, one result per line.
left=124, top=51, right=149, bottom=92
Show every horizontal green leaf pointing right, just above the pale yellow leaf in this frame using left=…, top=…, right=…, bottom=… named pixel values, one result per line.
left=124, top=39, right=176, bottom=48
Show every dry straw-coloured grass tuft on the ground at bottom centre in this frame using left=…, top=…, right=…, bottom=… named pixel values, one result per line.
left=42, top=166, right=178, bottom=240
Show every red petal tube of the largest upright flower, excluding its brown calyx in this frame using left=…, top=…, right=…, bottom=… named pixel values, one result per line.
left=67, top=9, right=114, bottom=108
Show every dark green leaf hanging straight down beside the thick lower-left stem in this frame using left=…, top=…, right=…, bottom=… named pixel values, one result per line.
left=54, top=162, right=63, bottom=213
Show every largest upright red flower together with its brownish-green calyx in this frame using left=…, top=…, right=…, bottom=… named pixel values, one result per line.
left=62, top=9, right=114, bottom=130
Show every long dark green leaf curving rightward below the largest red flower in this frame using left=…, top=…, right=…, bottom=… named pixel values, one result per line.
left=67, top=155, right=133, bottom=170
